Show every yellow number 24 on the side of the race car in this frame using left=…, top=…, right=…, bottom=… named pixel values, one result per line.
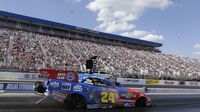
left=101, top=91, right=115, bottom=103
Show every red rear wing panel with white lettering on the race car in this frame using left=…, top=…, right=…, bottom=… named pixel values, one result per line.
left=39, top=69, right=78, bottom=82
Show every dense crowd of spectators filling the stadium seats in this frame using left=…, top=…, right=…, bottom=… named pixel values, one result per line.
left=0, top=28, right=200, bottom=80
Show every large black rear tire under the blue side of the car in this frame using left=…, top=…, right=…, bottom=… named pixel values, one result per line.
left=64, top=94, right=87, bottom=109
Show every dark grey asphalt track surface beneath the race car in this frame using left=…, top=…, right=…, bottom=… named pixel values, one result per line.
left=0, top=93, right=200, bottom=112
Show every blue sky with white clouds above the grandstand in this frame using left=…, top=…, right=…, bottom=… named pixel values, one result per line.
left=0, top=0, right=200, bottom=59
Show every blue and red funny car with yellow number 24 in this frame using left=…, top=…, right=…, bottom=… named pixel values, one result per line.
left=35, top=69, right=151, bottom=109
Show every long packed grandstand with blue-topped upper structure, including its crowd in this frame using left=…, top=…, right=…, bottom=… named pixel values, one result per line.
left=0, top=11, right=200, bottom=80
